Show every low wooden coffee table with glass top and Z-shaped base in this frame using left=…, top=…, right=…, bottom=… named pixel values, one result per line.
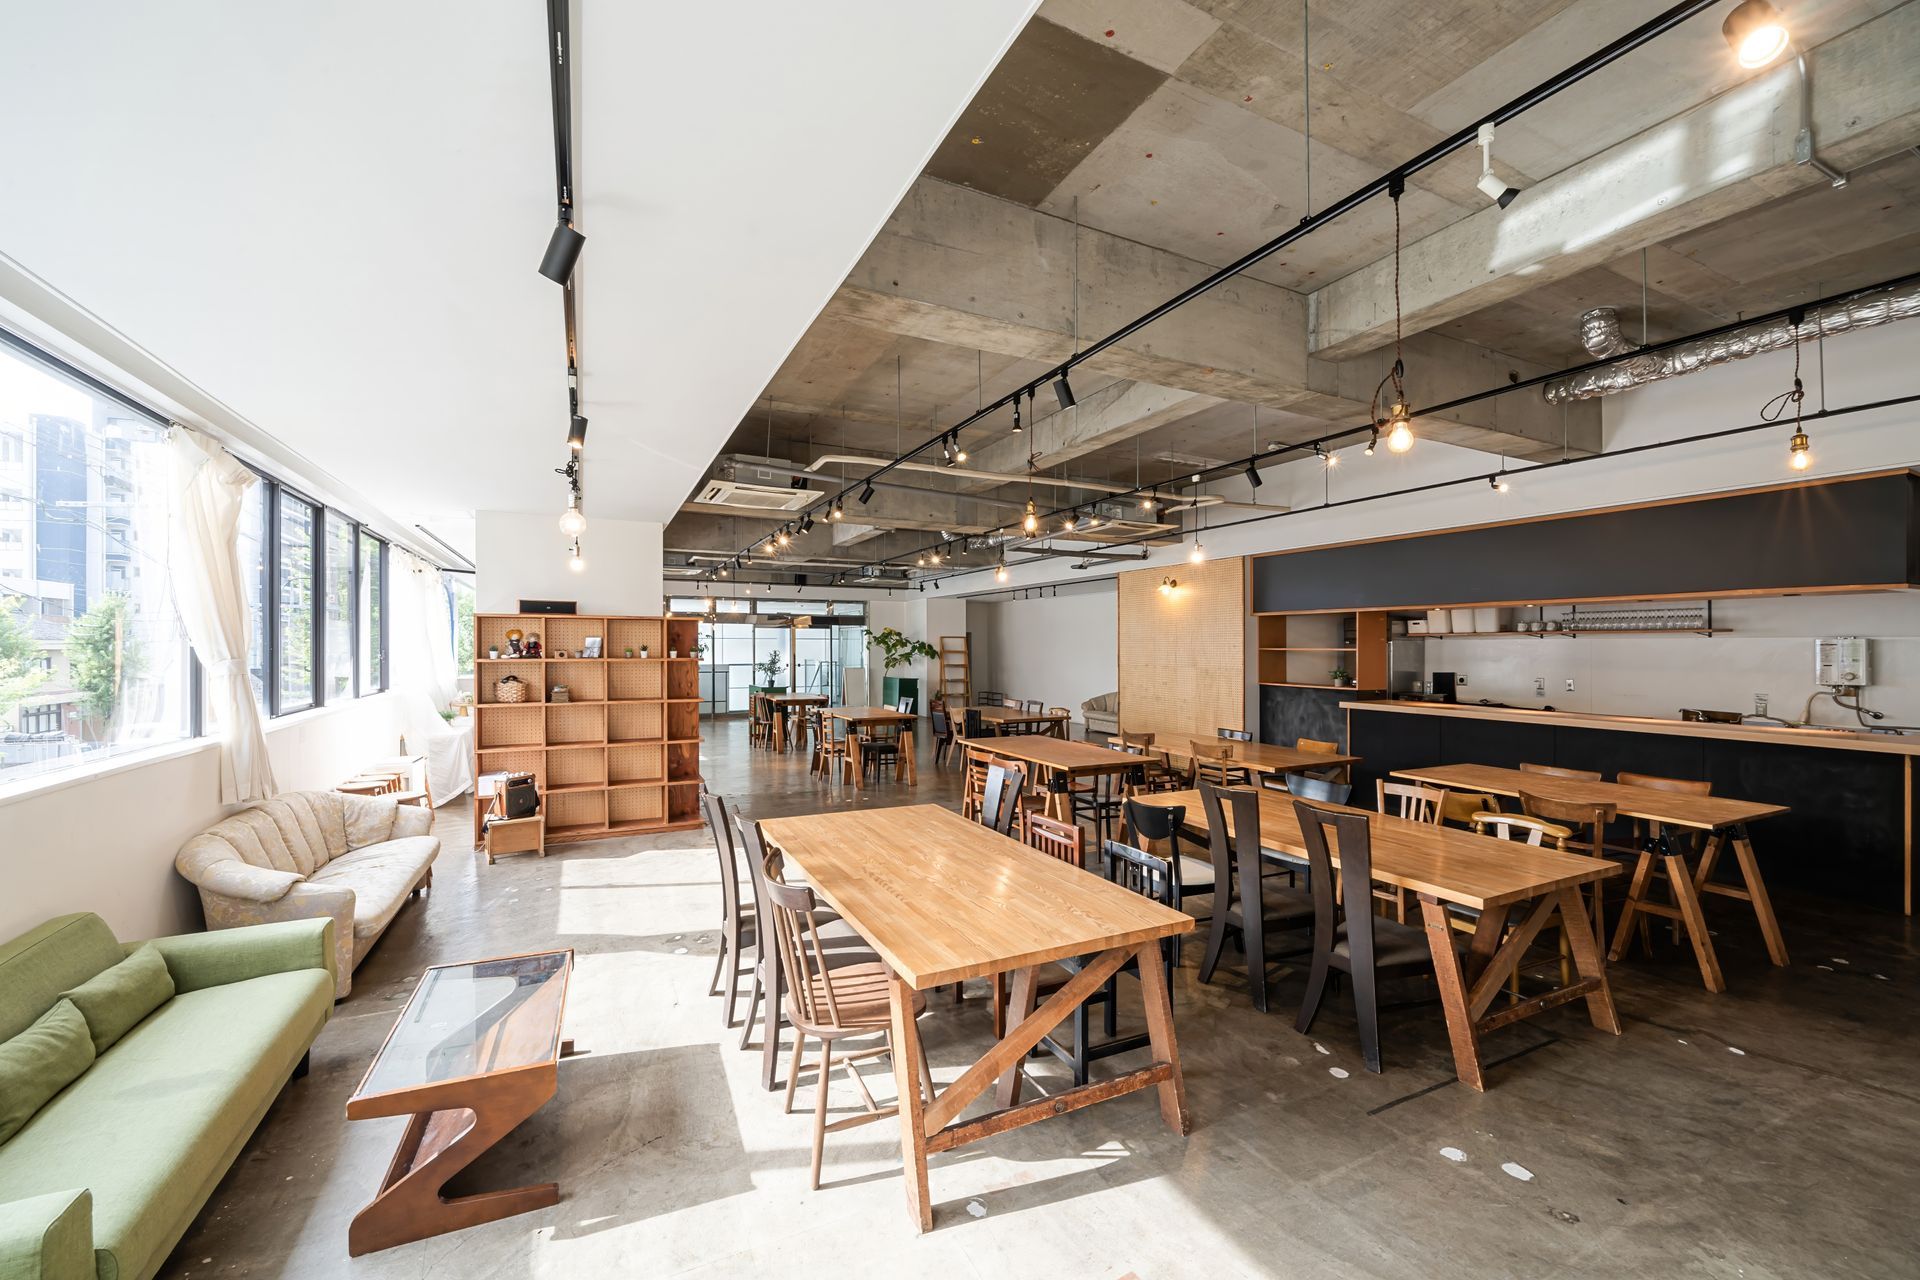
left=348, top=950, right=574, bottom=1257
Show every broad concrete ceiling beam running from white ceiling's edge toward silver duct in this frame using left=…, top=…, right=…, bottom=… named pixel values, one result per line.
left=829, top=178, right=1599, bottom=457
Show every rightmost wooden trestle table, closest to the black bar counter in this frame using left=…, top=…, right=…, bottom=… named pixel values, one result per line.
left=1394, top=764, right=1788, bottom=992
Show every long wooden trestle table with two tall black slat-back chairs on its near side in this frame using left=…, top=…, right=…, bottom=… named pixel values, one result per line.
left=1135, top=787, right=1620, bottom=1092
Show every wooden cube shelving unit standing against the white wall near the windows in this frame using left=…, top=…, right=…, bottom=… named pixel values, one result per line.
left=474, top=614, right=701, bottom=844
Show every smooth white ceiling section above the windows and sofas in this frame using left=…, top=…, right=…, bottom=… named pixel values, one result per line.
left=0, top=0, right=1035, bottom=541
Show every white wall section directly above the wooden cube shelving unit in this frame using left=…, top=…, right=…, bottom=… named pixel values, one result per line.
left=474, top=507, right=662, bottom=614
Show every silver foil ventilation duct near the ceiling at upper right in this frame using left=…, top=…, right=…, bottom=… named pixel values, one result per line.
left=1546, top=282, right=1920, bottom=405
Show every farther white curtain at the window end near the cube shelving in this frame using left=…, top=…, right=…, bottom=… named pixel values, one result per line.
left=386, top=547, right=474, bottom=804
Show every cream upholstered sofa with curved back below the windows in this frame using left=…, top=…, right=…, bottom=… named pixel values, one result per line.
left=173, top=791, right=440, bottom=1000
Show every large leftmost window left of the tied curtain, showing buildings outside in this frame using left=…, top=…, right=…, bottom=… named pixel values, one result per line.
left=0, top=328, right=194, bottom=781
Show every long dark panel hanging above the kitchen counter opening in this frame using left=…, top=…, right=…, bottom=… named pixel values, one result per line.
left=1252, top=472, right=1920, bottom=612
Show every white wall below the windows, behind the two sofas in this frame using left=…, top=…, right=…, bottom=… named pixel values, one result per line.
left=0, top=695, right=399, bottom=940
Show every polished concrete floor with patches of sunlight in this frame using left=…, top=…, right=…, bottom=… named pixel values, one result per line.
left=163, top=723, right=1920, bottom=1280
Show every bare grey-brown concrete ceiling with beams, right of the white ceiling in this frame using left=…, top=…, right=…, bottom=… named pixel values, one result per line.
left=668, top=0, right=1920, bottom=579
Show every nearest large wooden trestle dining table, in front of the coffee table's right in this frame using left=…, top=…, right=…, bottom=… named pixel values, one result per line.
left=760, top=804, right=1194, bottom=1232
